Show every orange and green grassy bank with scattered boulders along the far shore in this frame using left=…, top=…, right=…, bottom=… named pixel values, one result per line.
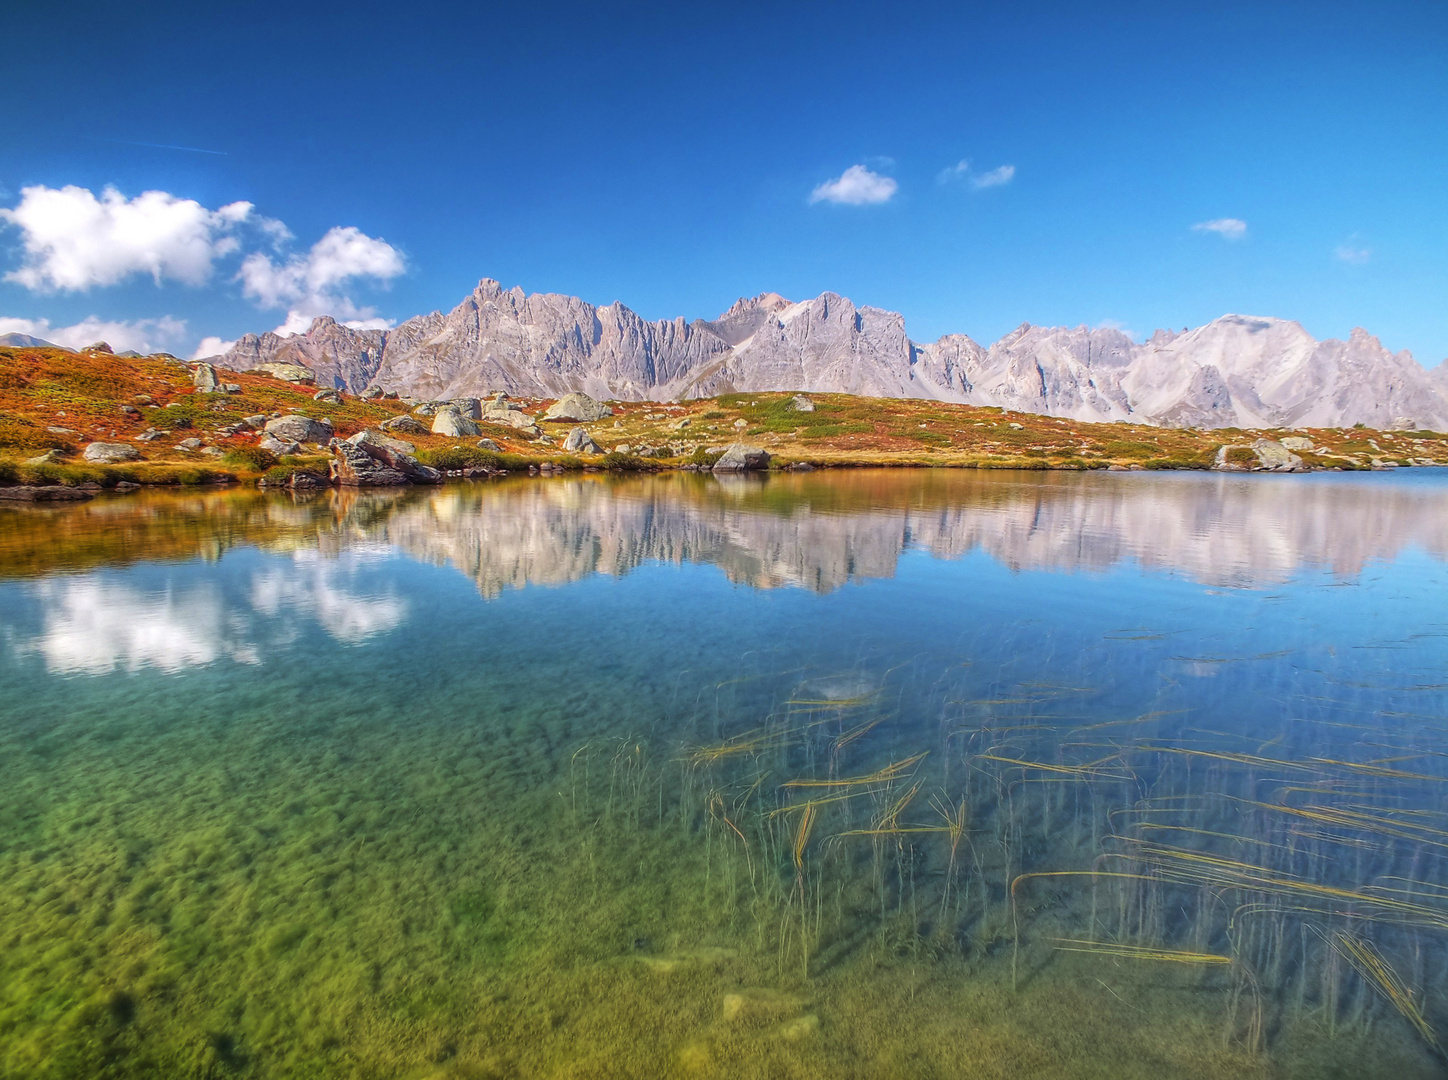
left=0, top=349, right=1448, bottom=488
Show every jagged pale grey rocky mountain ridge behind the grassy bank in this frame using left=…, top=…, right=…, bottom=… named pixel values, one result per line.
left=192, top=279, right=1448, bottom=430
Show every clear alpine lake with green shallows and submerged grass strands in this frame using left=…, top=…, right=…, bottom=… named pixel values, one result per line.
left=0, top=469, right=1448, bottom=1080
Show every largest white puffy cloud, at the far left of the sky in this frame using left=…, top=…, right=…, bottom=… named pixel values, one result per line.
left=0, top=185, right=252, bottom=291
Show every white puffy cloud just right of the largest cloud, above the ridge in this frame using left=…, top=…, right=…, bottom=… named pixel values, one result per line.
left=236, top=226, right=407, bottom=334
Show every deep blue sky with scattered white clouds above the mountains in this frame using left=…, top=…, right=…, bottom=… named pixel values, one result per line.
left=0, top=0, right=1448, bottom=366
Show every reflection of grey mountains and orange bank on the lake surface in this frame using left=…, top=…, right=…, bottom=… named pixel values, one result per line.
left=0, top=471, right=1448, bottom=593
